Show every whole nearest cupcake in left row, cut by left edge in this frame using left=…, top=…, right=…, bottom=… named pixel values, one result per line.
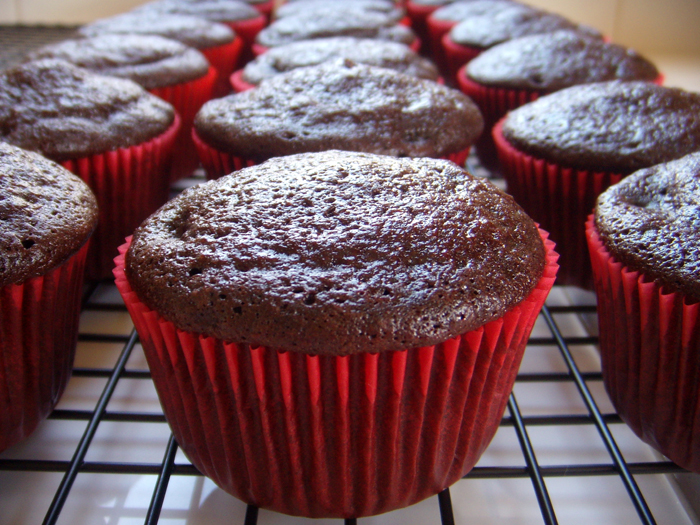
left=0, top=142, right=97, bottom=451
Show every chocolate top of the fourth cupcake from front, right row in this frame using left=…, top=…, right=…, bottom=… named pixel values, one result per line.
left=450, top=0, right=601, bottom=49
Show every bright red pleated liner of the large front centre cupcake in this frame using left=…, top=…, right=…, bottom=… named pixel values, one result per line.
left=114, top=232, right=557, bottom=517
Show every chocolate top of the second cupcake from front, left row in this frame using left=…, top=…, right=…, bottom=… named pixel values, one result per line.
left=0, top=59, right=175, bottom=160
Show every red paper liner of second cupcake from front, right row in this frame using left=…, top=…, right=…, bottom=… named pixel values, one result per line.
left=493, top=119, right=623, bottom=290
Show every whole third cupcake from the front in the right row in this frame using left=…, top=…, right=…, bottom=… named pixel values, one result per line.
left=457, top=30, right=661, bottom=166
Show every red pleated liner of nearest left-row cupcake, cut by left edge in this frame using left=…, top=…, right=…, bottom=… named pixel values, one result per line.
left=0, top=244, right=88, bottom=451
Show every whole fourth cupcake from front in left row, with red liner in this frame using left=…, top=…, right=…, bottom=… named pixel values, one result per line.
left=78, top=12, right=243, bottom=99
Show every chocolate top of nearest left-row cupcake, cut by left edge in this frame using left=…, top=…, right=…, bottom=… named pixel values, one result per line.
left=0, top=142, right=98, bottom=287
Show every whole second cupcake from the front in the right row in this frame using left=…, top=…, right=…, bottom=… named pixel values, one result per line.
left=493, top=81, right=700, bottom=289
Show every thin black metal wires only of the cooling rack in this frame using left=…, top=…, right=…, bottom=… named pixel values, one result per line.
left=0, top=26, right=696, bottom=525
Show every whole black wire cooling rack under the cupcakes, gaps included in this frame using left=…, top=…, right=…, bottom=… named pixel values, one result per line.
left=0, top=26, right=700, bottom=525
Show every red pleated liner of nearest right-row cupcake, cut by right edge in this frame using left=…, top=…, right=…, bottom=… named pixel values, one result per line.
left=586, top=216, right=700, bottom=473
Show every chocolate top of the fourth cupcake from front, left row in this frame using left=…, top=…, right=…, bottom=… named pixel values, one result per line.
left=78, top=12, right=236, bottom=50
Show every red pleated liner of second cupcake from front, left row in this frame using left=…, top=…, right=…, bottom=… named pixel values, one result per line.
left=60, top=113, right=180, bottom=280
